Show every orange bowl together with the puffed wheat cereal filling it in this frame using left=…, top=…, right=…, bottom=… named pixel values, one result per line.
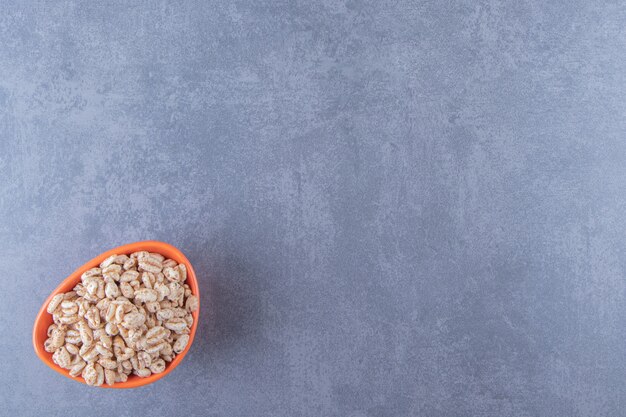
left=33, top=241, right=200, bottom=388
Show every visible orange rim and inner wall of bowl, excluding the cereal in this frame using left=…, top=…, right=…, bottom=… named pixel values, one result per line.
left=33, top=240, right=200, bottom=388
